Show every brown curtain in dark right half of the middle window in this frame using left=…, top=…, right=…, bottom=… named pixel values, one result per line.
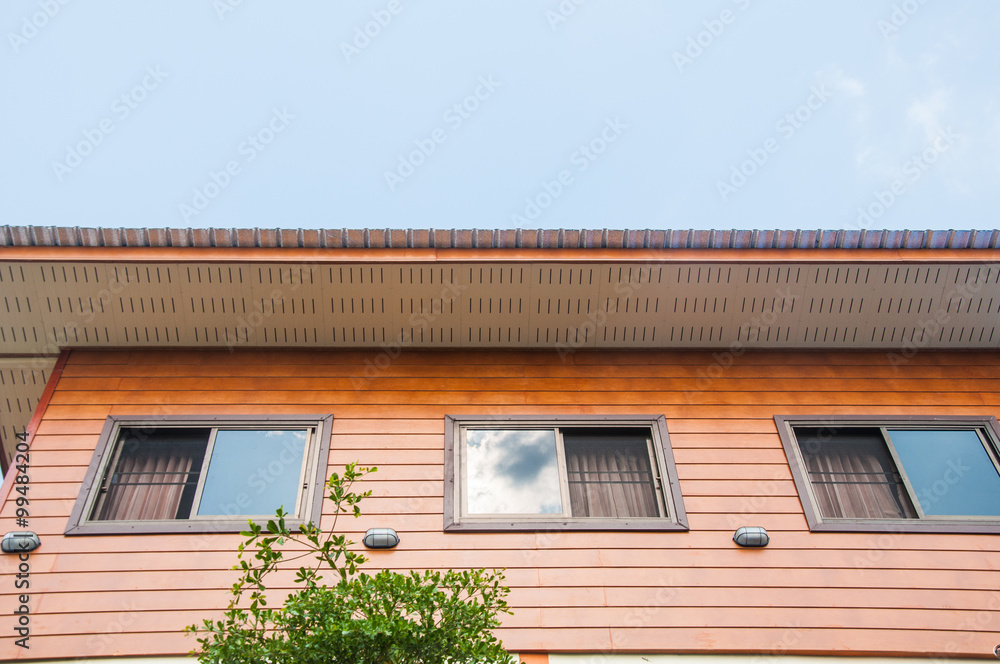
left=563, top=433, right=660, bottom=518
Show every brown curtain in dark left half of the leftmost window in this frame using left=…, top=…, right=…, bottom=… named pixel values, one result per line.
left=93, top=431, right=207, bottom=521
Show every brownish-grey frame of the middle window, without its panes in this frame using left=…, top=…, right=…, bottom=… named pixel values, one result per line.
left=444, top=415, right=688, bottom=532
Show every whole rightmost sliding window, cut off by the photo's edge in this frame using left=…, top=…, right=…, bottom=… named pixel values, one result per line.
left=775, top=417, right=1000, bottom=532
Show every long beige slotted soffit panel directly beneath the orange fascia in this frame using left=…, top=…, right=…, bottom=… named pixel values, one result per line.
left=0, top=262, right=1000, bottom=354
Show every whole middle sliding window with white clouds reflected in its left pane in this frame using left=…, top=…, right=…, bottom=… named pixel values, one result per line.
left=445, top=416, right=687, bottom=531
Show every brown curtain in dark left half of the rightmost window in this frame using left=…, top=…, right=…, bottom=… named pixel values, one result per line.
left=796, top=429, right=917, bottom=519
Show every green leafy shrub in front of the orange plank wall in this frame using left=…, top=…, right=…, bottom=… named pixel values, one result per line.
left=186, top=464, right=510, bottom=664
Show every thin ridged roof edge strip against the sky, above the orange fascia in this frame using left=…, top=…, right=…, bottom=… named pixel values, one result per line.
left=0, top=226, right=1000, bottom=249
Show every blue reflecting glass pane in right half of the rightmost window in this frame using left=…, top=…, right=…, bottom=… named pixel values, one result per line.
left=889, top=429, right=1000, bottom=516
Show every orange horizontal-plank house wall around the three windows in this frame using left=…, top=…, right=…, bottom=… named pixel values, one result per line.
left=0, top=350, right=1000, bottom=659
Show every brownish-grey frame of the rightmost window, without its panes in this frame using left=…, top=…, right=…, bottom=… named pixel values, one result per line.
left=774, top=415, right=1000, bottom=534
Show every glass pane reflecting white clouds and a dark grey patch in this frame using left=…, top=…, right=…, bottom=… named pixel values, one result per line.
left=465, top=429, right=563, bottom=514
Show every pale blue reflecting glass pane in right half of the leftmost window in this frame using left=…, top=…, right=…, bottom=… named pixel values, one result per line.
left=198, top=429, right=308, bottom=516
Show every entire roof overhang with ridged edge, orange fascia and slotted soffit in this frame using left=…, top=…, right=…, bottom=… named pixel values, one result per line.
left=0, top=227, right=1000, bottom=470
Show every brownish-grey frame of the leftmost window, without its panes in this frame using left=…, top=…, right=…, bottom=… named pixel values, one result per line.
left=64, top=415, right=333, bottom=535
